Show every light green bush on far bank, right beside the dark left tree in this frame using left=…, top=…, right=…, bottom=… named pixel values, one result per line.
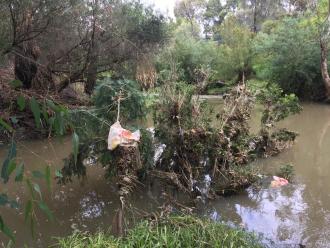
left=156, top=22, right=218, bottom=84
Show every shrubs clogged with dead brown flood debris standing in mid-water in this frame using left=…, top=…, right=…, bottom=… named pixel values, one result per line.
left=152, top=83, right=295, bottom=197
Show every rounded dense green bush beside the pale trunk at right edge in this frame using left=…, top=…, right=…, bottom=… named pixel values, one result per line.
left=254, top=18, right=324, bottom=100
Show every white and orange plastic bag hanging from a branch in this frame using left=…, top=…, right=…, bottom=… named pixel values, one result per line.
left=108, top=121, right=141, bottom=151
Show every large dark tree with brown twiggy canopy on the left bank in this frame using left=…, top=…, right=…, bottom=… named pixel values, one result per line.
left=0, top=0, right=166, bottom=94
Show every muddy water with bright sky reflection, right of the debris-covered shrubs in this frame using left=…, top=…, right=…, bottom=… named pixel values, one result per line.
left=202, top=104, right=330, bottom=247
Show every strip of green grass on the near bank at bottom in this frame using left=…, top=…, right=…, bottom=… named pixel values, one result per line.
left=54, top=216, right=263, bottom=248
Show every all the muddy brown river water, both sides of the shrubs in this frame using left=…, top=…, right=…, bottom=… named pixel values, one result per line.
left=0, top=99, right=330, bottom=247
